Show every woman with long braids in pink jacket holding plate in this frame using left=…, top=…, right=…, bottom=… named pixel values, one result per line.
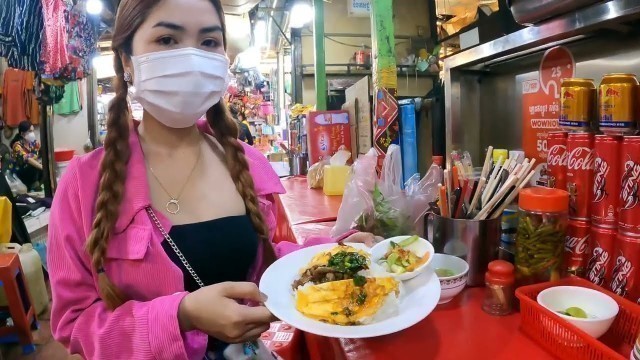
left=48, top=0, right=372, bottom=360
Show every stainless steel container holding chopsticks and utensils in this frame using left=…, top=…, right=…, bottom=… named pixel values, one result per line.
left=427, top=214, right=501, bottom=286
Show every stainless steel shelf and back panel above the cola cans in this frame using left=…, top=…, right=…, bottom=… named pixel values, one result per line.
left=444, top=0, right=640, bottom=162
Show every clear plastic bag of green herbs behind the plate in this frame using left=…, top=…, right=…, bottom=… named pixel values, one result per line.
left=331, top=145, right=443, bottom=238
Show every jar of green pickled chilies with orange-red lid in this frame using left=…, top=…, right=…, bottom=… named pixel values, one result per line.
left=515, top=187, right=569, bottom=286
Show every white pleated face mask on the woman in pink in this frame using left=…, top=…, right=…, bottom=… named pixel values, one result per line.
left=131, top=48, right=229, bottom=128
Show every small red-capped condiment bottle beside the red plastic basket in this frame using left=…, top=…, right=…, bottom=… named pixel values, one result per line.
left=482, top=260, right=515, bottom=316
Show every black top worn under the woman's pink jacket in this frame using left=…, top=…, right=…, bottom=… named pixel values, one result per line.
left=162, top=215, right=259, bottom=360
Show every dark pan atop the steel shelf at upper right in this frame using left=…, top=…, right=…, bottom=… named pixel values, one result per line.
left=509, top=0, right=599, bottom=25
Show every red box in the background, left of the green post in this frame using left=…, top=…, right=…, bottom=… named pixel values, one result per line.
left=307, top=111, right=351, bottom=166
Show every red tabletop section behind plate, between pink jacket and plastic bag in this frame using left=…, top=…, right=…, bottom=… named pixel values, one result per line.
left=275, top=177, right=342, bottom=242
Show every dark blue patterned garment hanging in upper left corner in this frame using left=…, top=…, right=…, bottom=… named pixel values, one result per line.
left=0, top=0, right=44, bottom=71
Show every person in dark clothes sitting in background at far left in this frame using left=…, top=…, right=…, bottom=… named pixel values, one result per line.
left=10, top=120, right=43, bottom=190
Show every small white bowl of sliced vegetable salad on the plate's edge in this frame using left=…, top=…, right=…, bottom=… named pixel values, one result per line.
left=371, top=236, right=434, bottom=281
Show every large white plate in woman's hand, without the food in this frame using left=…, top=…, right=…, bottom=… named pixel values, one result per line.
left=260, top=244, right=440, bottom=339
